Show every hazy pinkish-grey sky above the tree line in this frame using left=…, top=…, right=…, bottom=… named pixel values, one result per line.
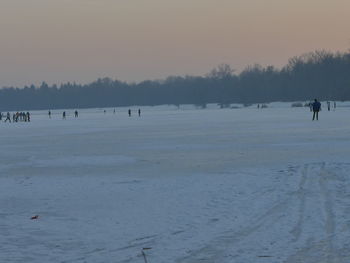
left=0, top=0, right=350, bottom=86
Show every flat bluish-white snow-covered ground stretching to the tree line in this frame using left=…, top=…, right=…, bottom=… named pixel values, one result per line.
left=0, top=103, right=350, bottom=263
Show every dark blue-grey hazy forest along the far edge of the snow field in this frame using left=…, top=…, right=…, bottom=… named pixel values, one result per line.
left=0, top=51, right=350, bottom=111
